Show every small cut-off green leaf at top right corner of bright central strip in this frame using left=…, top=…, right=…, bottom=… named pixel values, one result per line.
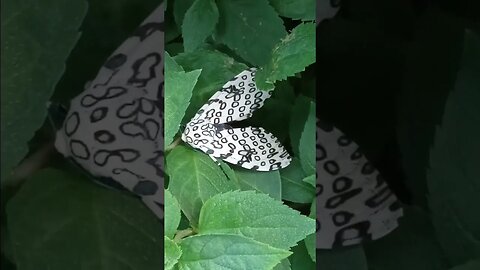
left=270, top=0, right=316, bottom=21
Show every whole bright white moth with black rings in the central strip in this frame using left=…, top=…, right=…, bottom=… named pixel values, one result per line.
left=181, top=68, right=291, bottom=171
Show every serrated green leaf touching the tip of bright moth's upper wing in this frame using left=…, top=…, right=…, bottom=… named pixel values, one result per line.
left=256, top=23, right=315, bottom=89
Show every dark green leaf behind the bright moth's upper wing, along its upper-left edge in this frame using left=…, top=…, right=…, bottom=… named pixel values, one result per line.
left=174, top=49, right=248, bottom=121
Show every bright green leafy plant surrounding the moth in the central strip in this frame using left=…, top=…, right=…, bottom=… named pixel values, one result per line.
left=165, top=0, right=315, bottom=269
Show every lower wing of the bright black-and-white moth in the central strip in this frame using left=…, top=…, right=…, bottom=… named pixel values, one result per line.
left=213, top=127, right=292, bottom=171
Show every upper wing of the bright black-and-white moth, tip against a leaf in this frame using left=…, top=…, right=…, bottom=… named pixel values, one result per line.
left=192, top=68, right=271, bottom=124
